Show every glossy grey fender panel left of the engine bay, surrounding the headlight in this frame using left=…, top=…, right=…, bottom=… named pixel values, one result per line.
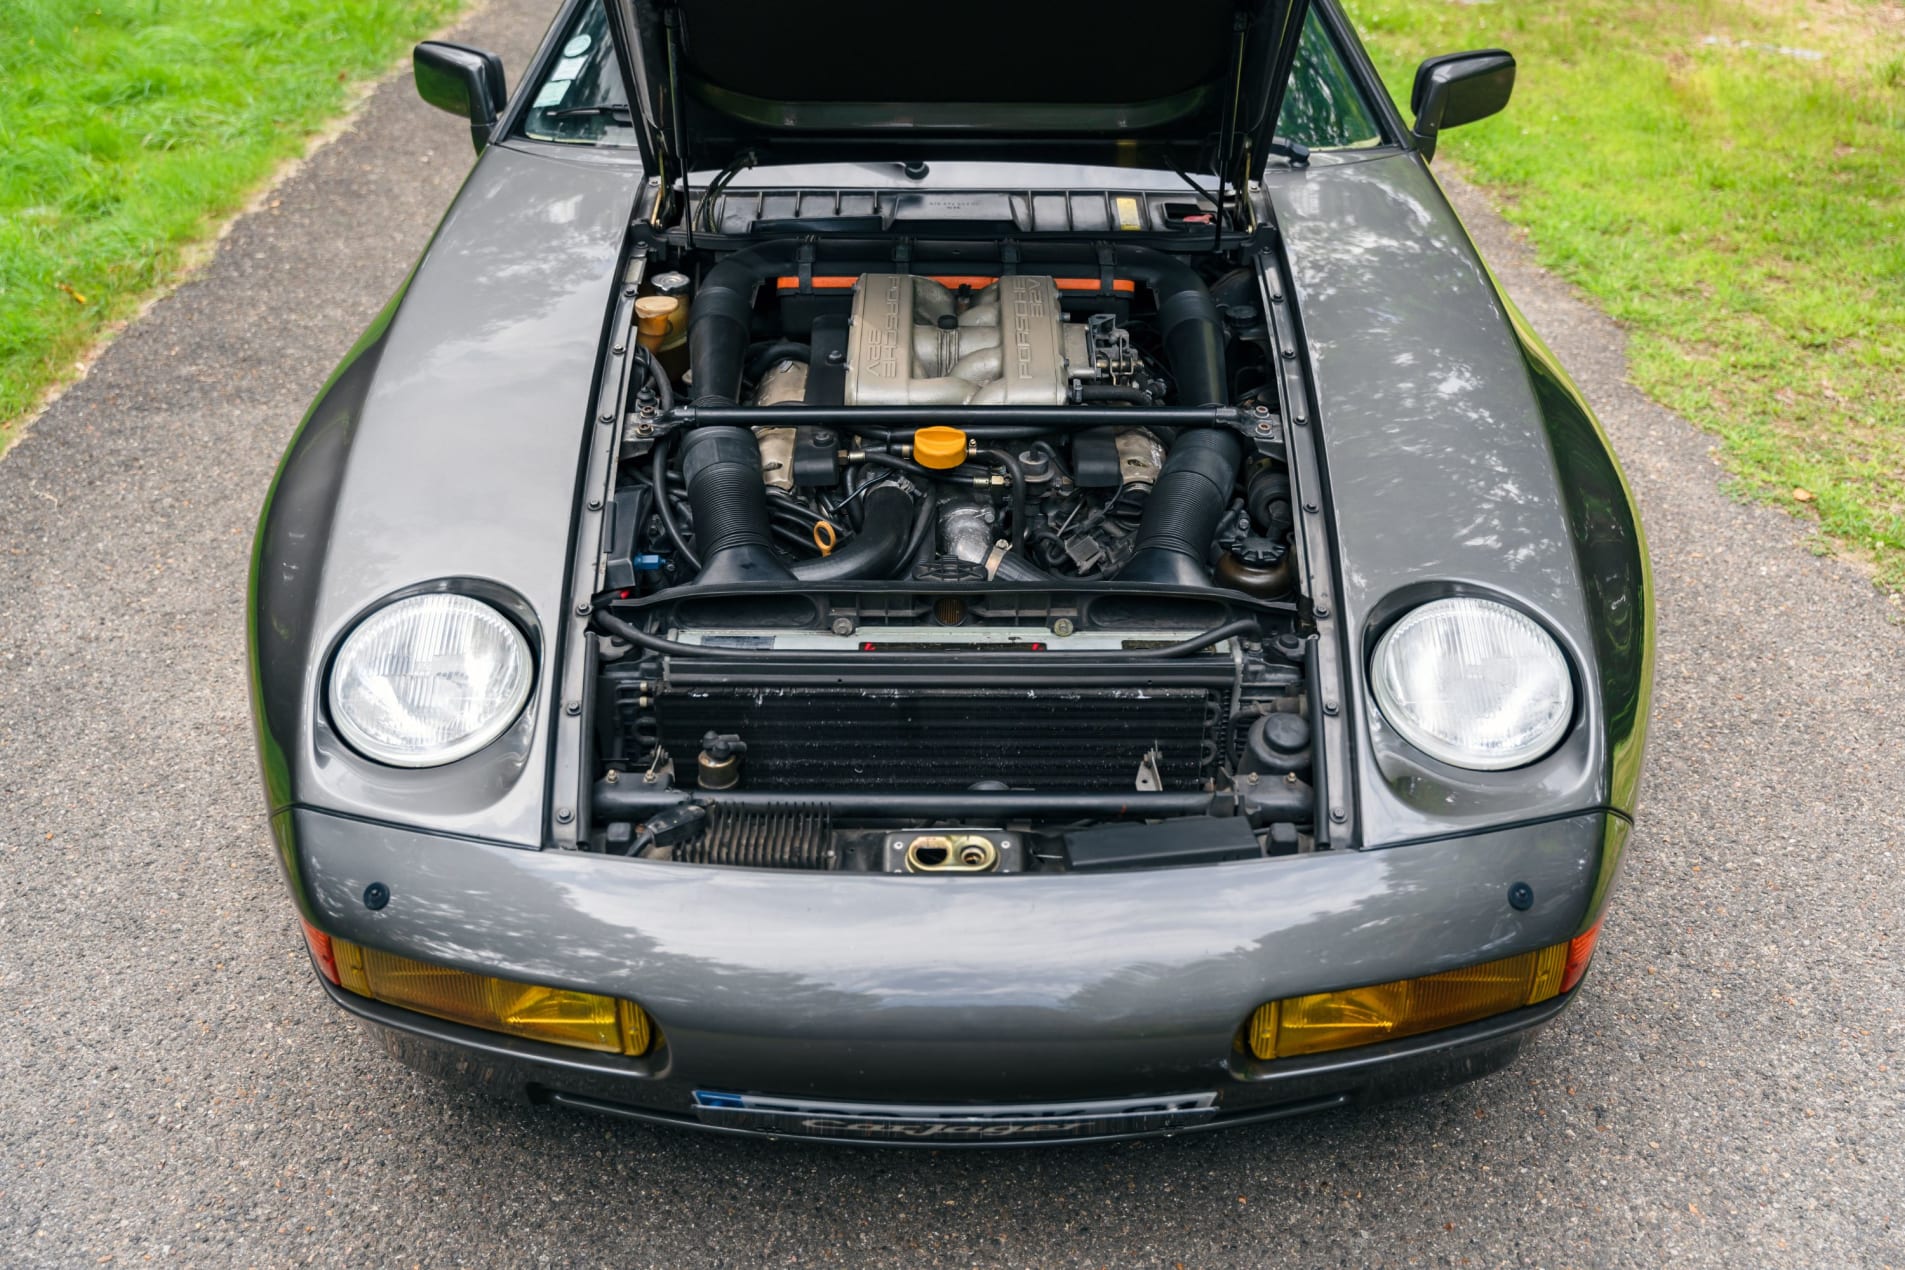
left=253, top=147, right=640, bottom=845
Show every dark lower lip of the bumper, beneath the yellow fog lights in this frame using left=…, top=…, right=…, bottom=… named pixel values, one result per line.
left=316, top=975, right=1562, bottom=1150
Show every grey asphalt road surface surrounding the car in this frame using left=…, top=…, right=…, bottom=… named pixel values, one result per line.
left=0, top=0, right=1905, bottom=1266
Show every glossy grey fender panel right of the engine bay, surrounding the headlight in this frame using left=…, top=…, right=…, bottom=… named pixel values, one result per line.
left=1265, top=154, right=1606, bottom=843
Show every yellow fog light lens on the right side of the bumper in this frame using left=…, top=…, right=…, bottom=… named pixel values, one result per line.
left=1246, top=944, right=1568, bottom=1059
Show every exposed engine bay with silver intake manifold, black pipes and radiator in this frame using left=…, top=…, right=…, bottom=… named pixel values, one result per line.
left=585, top=240, right=1320, bottom=874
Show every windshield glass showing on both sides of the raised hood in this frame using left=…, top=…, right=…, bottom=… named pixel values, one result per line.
left=522, top=0, right=1383, bottom=150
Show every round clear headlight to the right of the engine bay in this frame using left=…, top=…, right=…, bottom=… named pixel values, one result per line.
left=1370, top=598, right=1574, bottom=771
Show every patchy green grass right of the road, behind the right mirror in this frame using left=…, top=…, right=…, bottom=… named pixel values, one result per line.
left=1347, top=0, right=1905, bottom=588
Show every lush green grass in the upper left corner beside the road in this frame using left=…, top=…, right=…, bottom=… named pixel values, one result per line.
left=0, top=0, right=459, bottom=451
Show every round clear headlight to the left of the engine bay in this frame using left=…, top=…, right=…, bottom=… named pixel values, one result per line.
left=330, top=596, right=533, bottom=767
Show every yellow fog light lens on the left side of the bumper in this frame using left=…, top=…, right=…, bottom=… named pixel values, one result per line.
left=331, top=939, right=655, bottom=1055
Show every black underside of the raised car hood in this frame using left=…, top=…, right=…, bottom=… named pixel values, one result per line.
left=612, top=0, right=1309, bottom=177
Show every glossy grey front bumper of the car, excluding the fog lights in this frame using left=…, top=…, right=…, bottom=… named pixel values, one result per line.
left=274, top=811, right=1604, bottom=1144
